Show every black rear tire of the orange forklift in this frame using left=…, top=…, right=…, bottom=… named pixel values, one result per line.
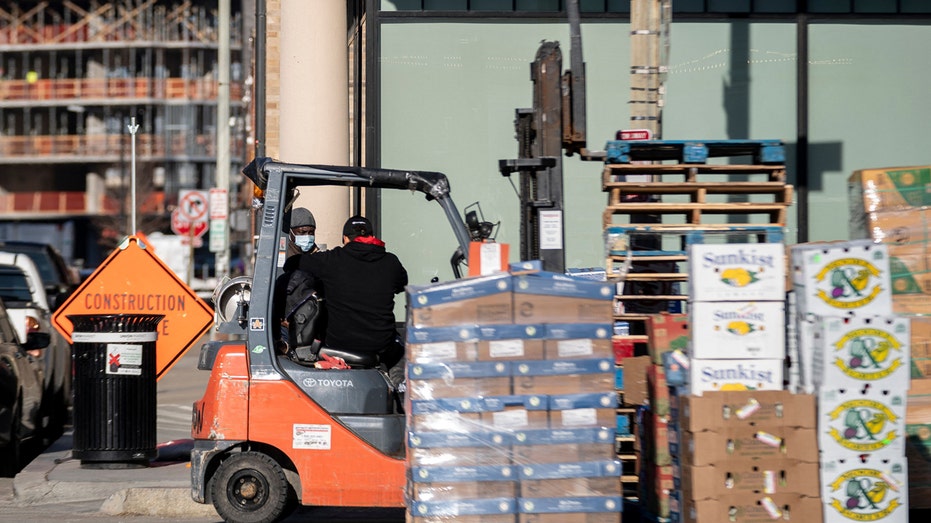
left=211, top=452, right=297, bottom=523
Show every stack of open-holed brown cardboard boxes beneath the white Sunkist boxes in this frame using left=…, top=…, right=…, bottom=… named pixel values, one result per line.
left=669, top=390, right=821, bottom=523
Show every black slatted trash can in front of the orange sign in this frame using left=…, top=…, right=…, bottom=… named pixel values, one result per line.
left=68, top=314, right=164, bottom=468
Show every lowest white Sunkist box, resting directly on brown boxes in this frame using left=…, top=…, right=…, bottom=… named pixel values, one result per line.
left=689, top=358, right=785, bottom=396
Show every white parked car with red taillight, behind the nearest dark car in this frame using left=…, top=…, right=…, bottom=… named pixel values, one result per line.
left=0, top=252, right=72, bottom=443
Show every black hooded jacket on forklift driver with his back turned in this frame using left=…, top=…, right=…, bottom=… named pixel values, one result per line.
left=285, top=237, right=407, bottom=352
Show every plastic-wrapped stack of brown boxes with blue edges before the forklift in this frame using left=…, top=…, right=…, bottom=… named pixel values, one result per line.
left=407, top=271, right=622, bottom=523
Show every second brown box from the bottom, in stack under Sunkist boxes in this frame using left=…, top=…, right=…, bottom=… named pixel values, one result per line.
left=673, top=458, right=821, bottom=500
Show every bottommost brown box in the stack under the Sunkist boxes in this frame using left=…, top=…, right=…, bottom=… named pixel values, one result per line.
left=672, top=494, right=822, bottom=523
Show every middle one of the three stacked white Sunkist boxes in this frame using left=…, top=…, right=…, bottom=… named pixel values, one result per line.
left=689, top=301, right=786, bottom=359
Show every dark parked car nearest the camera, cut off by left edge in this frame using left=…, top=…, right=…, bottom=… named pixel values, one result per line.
left=0, top=300, right=51, bottom=477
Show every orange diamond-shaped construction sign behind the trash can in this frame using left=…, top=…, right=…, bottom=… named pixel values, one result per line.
left=52, top=236, right=213, bottom=379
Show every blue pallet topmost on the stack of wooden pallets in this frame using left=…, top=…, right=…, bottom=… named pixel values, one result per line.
left=605, top=140, right=786, bottom=164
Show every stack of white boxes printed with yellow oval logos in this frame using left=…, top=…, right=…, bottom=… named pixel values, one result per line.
left=791, top=240, right=910, bottom=523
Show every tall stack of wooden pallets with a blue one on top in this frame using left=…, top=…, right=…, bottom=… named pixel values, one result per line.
left=602, top=140, right=793, bottom=517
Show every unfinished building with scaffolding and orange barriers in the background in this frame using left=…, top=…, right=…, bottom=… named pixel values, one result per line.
left=0, top=0, right=253, bottom=264
